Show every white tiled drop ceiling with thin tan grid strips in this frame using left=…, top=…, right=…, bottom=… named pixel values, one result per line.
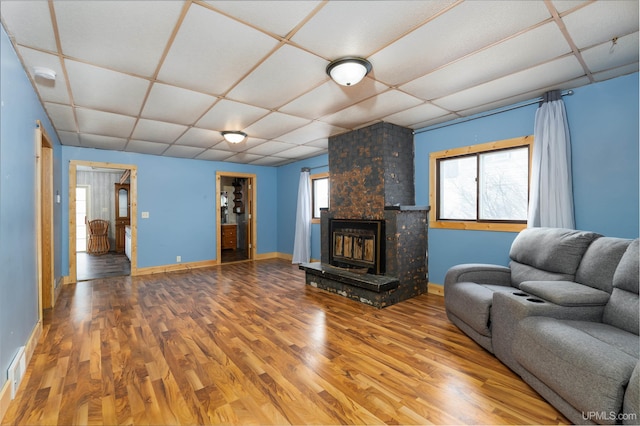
left=0, top=0, right=639, bottom=166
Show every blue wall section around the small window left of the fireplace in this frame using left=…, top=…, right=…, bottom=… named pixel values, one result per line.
left=278, top=154, right=329, bottom=260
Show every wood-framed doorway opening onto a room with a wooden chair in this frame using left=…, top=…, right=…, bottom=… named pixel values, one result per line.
left=69, top=160, right=137, bottom=282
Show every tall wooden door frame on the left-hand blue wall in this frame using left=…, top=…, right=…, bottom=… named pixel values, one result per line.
left=35, top=120, right=56, bottom=321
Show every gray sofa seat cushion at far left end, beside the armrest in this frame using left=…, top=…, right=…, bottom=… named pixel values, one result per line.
left=444, top=282, right=515, bottom=337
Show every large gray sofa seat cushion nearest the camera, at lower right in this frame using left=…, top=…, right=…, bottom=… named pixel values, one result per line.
left=513, top=317, right=640, bottom=420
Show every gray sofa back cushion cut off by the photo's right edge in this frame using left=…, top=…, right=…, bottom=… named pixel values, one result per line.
left=602, top=239, right=640, bottom=335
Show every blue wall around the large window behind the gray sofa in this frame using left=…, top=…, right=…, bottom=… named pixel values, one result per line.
left=415, top=73, right=639, bottom=284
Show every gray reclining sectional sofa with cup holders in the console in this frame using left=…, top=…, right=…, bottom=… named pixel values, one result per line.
left=444, top=228, right=640, bottom=424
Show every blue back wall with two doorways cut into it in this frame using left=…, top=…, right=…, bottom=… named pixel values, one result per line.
left=62, top=146, right=278, bottom=274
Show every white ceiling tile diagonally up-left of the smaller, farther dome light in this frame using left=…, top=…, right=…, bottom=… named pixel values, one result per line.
left=142, top=83, right=216, bottom=125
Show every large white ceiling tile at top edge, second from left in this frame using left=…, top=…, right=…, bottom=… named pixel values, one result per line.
left=53, top=1, right=182, bottom=77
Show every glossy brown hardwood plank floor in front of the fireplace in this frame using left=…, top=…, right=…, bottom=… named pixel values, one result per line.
left=3, top=260, right=568, bottom=425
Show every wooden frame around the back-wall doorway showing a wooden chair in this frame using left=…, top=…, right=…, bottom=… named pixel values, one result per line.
left=66, top=160, right=138, bottom=283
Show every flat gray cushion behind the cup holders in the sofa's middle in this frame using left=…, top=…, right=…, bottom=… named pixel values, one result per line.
left=520, top=281, right=610, bottom=306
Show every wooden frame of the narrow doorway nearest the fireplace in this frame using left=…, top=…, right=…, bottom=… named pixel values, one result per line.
left=216, top=171, right=258, bottom=264
